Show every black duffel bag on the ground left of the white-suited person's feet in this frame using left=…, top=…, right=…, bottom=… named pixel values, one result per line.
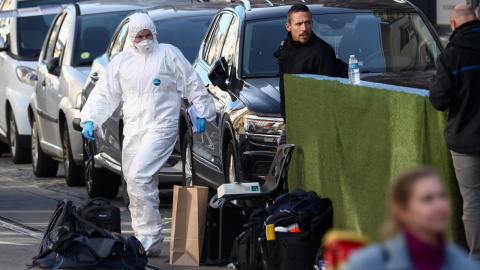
left=33, top=200, right=148, bottom=269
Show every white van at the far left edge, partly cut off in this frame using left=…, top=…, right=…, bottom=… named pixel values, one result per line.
left=0, top=0, right=92, bottom=163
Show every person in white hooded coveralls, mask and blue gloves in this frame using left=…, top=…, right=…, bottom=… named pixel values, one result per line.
left=81, top=14, right=215, bottom=256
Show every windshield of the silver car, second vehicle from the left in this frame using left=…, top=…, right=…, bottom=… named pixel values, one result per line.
left=73, top=11, right=130, bottom=66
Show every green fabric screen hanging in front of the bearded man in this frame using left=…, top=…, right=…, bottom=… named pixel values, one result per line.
left=285, top=75, right=465, bottom=244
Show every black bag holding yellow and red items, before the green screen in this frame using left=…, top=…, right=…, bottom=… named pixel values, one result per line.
left=260, top=189, right=333, bottom=270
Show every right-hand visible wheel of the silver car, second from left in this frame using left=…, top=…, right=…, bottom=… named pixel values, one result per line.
left=62, top=122, right=85, bottom=187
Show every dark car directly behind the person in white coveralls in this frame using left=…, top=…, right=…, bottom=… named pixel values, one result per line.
left=76, top=3, right=226, bottom=200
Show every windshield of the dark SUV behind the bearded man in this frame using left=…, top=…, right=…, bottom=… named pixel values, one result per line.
left=243, top=13, right=440, bottom=77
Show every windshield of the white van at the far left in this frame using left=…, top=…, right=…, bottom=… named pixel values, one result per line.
left=17, top=0, right=85, bottom=57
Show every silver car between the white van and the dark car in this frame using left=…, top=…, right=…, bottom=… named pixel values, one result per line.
left=28, top=1, right=159, bottom=186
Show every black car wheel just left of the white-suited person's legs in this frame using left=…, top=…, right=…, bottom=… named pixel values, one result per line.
left=83, top=139, right=120, bottom=199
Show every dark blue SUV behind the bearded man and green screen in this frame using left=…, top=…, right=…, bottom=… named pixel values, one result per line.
left=180, top=0, right=442, bottom=188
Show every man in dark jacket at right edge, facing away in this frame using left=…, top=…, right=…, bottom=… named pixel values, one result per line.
left=430, top=5, right=480, bottom=261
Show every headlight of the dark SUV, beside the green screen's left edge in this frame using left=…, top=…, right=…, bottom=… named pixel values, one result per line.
left=243, top=115, right=284, bottom=143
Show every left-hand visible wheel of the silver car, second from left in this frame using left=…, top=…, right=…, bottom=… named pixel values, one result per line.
left=31, top=119, right=58, bottom=177
